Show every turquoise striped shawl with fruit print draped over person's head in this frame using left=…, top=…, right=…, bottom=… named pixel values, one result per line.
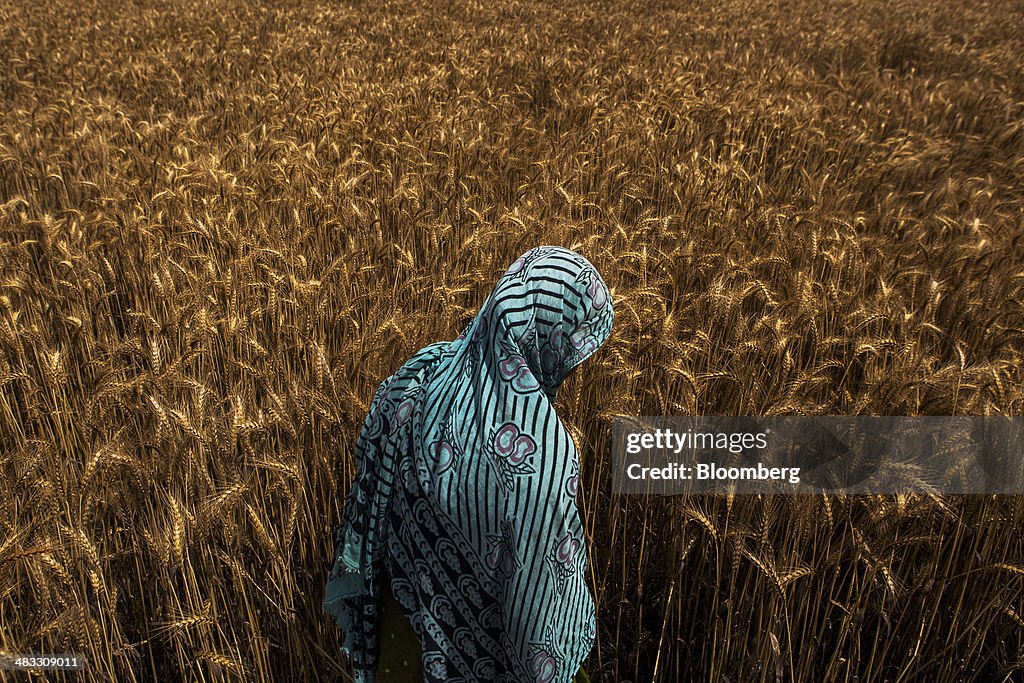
left=324, top=247, right=612, bottom=683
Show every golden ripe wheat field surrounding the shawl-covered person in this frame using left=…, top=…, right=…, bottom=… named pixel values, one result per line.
left=0, top=0, right=1024, bottom=683
